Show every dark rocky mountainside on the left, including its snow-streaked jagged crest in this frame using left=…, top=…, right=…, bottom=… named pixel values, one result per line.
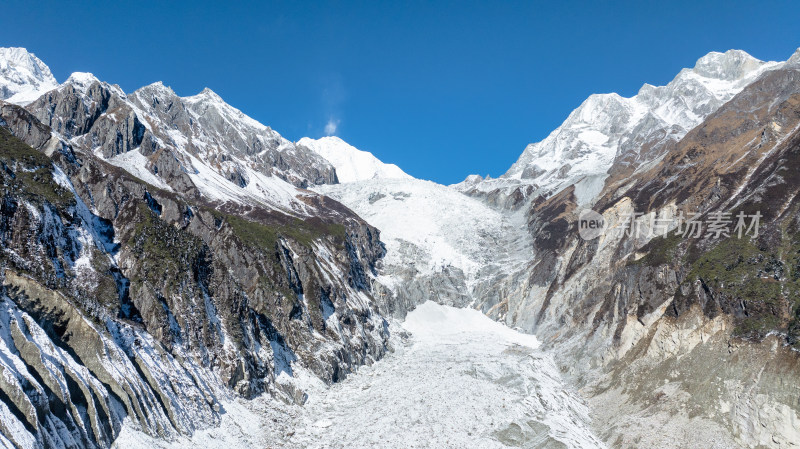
left=0, top=51, right=388, bottom=447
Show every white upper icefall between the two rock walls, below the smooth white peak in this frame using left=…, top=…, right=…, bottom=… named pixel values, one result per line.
left=314, top=173, right=532, bottom=316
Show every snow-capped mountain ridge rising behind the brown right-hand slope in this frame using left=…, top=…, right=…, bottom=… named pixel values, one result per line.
left=455, top=50, right=782, bottom=203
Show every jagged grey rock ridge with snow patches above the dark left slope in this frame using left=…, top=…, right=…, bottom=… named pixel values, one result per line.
left=14, top=51, right=336, bottom=215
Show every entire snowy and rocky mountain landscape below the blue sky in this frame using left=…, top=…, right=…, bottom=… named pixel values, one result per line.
left=0, top=42, right=800, bottom=448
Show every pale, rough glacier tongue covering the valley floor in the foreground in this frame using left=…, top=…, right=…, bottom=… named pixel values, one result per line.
left=111, top=302, right=604, bottom=449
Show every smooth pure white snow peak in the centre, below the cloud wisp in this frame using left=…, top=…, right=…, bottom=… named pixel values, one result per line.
left=297, top=136, right=411, bottom=182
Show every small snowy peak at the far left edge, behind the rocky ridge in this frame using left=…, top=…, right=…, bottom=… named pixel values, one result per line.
left=0, top=47, right=58, bottom=105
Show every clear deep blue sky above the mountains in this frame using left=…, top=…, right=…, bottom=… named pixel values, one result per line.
left=0, top=0, right=800, bottom=183
